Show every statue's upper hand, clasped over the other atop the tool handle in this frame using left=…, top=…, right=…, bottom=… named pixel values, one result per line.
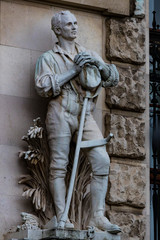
left=74, top=52, right=99, bottom=73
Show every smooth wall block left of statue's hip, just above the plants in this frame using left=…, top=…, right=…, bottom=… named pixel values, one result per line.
left=0, top=95, right=46, bottom=148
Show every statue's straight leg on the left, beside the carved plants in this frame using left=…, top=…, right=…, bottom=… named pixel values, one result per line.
left=46, top=101, right=74, bottom=228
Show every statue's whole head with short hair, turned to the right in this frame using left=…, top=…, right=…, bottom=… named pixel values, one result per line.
left=51, top=11, right=78, bottom=40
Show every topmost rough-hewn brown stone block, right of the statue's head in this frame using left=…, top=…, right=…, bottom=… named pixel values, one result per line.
left=106, top=18, right=145, bottom=64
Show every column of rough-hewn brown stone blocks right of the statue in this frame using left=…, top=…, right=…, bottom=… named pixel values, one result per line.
left=106, top=12, right=149, bottom=240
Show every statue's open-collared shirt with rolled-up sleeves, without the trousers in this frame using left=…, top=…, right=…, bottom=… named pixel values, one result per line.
left=35, top=43, right=119, bottom=100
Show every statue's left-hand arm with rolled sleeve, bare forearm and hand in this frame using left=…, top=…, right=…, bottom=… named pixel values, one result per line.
left=35, top=54, right=88, bottom=97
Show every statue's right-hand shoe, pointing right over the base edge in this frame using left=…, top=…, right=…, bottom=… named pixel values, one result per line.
left=89, top=216, right=121, bottom=234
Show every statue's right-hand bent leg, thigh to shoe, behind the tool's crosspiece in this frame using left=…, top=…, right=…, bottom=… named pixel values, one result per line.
left=83, top=115, right=121, bottom=233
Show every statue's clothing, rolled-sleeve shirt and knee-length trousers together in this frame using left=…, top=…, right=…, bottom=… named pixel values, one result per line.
left=35, top=44, right=118, bottom=181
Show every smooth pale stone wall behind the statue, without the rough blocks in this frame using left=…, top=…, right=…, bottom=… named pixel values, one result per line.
left=0, top=0, right=105, bottom=240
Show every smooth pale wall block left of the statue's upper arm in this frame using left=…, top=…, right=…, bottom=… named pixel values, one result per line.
left=0, top=45, right=30, bottom=97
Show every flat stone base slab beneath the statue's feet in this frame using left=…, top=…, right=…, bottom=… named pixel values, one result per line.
left=5, top=229, right=121, bottom=240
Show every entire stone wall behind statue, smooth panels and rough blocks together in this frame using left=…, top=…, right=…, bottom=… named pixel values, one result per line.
left=0, top=0, right=149, bottom=240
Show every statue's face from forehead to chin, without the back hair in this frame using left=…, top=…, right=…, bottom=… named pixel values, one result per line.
left=59, top=14, right=78, bottom=40
